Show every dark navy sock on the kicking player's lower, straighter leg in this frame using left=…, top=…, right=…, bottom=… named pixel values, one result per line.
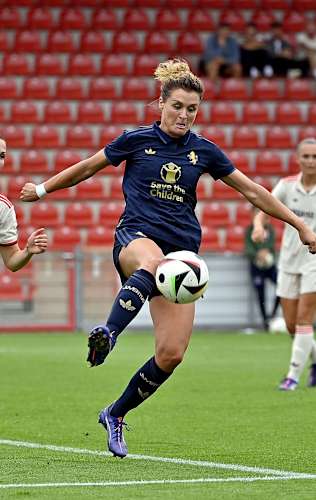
left=111, top=357, right=171, bottom=417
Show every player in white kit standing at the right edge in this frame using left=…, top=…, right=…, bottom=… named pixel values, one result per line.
left=252, top=138, right=316, bottom=391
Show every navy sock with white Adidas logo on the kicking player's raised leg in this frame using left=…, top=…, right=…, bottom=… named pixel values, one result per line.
left=106, top=269, right=156, bottom=337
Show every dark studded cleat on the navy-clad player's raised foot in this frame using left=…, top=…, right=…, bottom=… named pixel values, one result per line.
left=87, top=325, right=116, bottom=366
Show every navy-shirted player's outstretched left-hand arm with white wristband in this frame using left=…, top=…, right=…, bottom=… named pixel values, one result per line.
left=20, top=149, right=110, bottom=201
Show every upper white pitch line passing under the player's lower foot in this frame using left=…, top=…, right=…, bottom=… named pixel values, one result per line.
left=0, top=439, right=316, bottom=479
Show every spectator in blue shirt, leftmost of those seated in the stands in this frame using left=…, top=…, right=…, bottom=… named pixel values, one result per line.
left=202, top=24, right=241, bottom=81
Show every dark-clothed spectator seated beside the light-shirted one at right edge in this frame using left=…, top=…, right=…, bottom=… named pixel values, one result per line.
left=266, top=23, right=309, bottom=78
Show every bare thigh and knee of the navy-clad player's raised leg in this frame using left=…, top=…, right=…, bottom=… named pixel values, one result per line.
left=119, top=238, right=163, bottom=277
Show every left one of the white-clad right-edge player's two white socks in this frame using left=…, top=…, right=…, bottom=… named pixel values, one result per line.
left=287, top=325, right=314, bottom=382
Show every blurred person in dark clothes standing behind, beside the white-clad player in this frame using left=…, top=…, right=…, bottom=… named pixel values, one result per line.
left=245, top=217, right=280, bottom=330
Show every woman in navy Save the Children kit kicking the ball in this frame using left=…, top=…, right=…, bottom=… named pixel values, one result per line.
left=21, top=59, right=316, bottom=457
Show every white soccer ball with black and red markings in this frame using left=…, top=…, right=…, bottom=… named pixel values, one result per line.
left=156, top=250, right=209, bottom=304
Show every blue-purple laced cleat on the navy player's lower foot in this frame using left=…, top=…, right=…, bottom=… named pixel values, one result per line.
left=99, top=405, right=127, bottom=458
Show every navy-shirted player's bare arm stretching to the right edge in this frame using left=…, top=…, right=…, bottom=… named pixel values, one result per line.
left=222, top=170, right=316, bottom=253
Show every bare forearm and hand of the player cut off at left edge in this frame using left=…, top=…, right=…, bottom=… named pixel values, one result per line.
left=0, top=228, right=47, bottom=272
